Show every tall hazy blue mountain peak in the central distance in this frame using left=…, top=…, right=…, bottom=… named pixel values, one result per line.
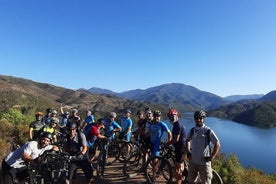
left=89, top=83, right=227, bottom=112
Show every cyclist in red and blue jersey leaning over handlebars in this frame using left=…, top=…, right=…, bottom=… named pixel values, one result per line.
left=84, top=118, right=107, bottom=162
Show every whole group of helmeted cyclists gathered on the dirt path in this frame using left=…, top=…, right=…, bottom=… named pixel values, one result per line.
left=2, top=107, right=220, bottom=184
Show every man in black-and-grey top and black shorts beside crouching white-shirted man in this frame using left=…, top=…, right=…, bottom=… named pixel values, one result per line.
left=64, top=123, right=93, bottom=183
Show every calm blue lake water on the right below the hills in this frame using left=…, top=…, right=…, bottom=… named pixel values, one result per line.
left=163, top=114, right=276, bottom=174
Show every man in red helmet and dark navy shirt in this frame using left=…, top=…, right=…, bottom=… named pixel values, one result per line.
left=165, top=108, right=186, bottom=184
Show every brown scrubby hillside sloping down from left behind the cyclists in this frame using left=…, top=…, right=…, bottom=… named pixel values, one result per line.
left=0, top=75, right=167, bottom=117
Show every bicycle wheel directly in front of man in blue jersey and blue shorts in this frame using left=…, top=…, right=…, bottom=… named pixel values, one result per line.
left=145, top=156, right=173, bottom=183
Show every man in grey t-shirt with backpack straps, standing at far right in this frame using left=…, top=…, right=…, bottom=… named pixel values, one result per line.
left=186, top=110, right=220, bottom=184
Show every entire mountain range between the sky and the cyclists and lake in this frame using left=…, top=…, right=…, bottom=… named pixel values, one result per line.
left=0, top=75, right=276, bottom=127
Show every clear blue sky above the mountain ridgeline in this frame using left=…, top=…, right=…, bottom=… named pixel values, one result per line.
left=0, top=0, right=276, bottom=97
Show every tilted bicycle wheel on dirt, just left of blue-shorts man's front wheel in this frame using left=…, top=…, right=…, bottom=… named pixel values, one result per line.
left=123, top=153, right=143, bottom=177
